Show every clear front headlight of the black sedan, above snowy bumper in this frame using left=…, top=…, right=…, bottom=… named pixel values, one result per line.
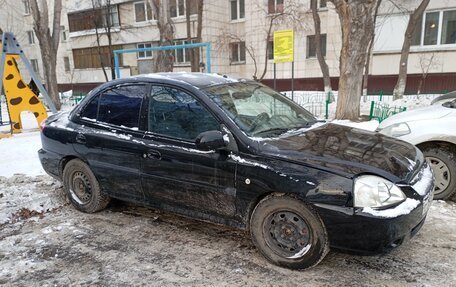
left=354, top=175, right=406, bottom=207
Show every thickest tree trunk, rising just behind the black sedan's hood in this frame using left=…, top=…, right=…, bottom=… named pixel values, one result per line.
left=331, top=0, right=381, bottom=120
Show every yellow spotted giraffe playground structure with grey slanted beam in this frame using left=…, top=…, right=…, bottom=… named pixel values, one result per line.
left=0, top=33, right=57, bottom=136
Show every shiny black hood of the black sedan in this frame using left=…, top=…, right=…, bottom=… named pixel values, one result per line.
left=260, top=124, right=423, bottom=183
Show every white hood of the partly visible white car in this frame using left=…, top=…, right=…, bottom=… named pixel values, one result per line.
left=379, top=104, right=456, bottom=129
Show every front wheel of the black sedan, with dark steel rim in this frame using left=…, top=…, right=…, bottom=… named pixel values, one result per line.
left=250, top=194, right=329, bottom=269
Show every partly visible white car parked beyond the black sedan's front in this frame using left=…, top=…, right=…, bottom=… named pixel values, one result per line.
left=377, top=97, right=456, bottom=200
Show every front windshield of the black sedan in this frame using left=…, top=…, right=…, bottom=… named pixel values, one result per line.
left=205, top=82, right=317, bottom=137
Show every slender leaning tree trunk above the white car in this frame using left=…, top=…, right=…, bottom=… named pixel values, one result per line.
left=393, top=0, right=430, bottom=100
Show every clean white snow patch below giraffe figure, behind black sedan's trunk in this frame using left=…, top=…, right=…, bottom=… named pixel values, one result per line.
left=0, top=131, right=45, bottom=177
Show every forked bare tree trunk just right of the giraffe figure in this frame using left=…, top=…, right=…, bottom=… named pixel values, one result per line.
left=30, top=0, right=62, bottom=110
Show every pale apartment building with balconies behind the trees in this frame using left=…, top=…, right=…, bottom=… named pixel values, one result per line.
left=0, top=0, right=456, bottom=92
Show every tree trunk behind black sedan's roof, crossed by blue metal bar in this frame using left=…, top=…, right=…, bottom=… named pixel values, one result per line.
left=150, top=0, right=174, bottom=72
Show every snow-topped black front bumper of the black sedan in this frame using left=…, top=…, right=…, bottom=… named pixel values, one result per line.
left=317, top=166, right=434, bottom=254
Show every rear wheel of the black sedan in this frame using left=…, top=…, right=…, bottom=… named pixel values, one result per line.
left=63, top=159, right=110, bottom=213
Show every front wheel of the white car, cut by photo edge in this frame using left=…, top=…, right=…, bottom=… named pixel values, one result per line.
left=420, top=144, right=456, bottom=200
